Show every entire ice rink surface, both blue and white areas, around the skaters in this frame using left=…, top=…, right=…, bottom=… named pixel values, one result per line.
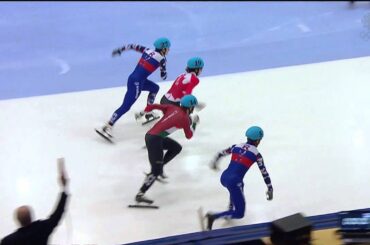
left=0, top=2, right=370, bottom=245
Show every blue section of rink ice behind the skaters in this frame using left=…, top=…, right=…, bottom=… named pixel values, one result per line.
left=0, top=2, right=370, bottom=100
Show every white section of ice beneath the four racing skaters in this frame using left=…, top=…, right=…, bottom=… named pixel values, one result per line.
left=0, top=57, right=370, bottom=245
